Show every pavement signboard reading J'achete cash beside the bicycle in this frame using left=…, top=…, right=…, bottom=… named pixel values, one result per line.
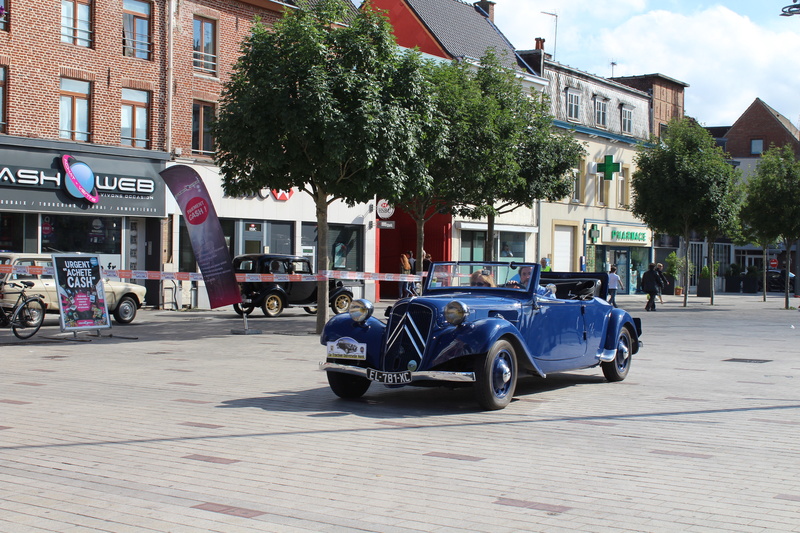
left=53, top=254, right=111, bottom=331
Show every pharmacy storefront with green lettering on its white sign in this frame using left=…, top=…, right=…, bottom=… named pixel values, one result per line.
left=585, top=222, right=653, bottom=294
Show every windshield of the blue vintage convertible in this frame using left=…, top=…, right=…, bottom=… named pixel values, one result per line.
left=427, top=262, right=534, bottom=291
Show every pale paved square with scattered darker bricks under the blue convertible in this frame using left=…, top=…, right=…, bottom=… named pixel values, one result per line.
left=0, top=295, right=800, bottom=533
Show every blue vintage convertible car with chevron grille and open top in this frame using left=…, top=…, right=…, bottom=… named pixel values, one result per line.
left=320, top=262, right=642, bottom=410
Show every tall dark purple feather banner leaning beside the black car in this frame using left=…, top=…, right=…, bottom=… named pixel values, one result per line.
left=161, top=165, right=242, bottom=309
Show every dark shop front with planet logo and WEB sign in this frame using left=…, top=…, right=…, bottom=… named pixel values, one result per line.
left=0, top=137, right=168, bottom=300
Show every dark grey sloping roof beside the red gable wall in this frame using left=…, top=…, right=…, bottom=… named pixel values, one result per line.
left=405, top=0, right=532, bottom=73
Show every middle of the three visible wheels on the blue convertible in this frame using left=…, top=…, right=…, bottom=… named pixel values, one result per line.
left=475, top=340, right=517, bottom=411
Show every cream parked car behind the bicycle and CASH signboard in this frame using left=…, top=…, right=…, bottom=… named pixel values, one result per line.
left=0, top=252, right=147, bottom=324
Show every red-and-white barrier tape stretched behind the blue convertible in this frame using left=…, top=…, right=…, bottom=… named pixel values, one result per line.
left=0, top=265, right=427, bottom=283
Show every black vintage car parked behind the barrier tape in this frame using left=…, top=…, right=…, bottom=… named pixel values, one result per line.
left=233, top=254, right=353, bottom=317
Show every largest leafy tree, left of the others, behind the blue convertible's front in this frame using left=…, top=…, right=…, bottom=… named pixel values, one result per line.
left=212, top=0, right=437, bottom=331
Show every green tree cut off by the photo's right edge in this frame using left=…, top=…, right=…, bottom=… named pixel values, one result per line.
left=742, top=144, right=800, bottom=309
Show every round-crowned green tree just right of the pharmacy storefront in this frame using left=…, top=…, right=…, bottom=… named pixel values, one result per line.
left=631, top=118, right=738, bottom=307
